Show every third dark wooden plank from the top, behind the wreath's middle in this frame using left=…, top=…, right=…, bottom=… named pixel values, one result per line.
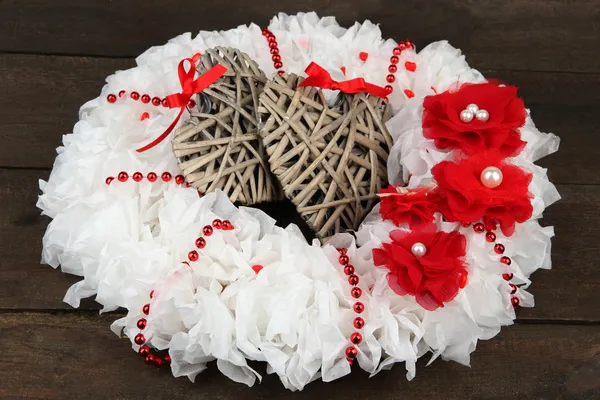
left=0, top=169, right=600, bottom=321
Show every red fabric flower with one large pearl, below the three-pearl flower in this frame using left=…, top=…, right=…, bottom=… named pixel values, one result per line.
left=431, top=151, right=533, bottom=236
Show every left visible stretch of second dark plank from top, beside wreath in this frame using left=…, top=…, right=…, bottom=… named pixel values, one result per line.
left=0, top=54, right=135, bottom=167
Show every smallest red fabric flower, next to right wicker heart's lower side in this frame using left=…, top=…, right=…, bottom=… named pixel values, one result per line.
left=379, top=186, right=437, bottom=229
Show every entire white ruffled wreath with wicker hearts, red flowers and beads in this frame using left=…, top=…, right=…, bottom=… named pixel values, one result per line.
left=38, top=13, right=559, bottom=390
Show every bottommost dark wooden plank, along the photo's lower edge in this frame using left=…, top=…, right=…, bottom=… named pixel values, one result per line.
left=0, top=313, right=600, bottom=400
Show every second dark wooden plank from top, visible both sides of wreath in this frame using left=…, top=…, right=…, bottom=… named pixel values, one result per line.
left=0, top=55, right=600, bottom=184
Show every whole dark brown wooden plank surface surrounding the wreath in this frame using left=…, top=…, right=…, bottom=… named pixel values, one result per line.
left=0, top=0, right=600, bottom=400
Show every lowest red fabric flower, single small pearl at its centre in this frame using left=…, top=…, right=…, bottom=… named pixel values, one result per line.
left=373, top=230, right=468, bottom=310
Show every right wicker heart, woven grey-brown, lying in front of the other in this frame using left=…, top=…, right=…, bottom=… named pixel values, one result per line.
left=259, top=75, right=392, bottom=239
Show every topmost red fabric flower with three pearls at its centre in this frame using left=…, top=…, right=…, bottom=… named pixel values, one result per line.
left=423, top=83, right=527, bottom=156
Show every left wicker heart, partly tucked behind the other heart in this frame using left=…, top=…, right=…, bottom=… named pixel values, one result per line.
left=173, top=47, right=281, bottom=204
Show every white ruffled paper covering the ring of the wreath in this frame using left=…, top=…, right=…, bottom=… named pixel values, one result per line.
left=38, top=13, right=559, bottom=390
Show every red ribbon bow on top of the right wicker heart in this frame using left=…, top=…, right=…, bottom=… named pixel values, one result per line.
left=298, top=62, right=388, bottom=99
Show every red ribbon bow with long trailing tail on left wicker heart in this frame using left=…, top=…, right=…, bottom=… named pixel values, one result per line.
left=137, top=53, right=227, bottom=153
